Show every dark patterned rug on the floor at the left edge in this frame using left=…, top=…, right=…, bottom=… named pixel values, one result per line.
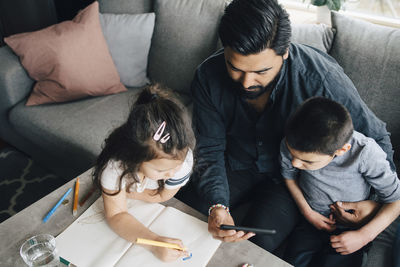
left=0, top=147, right=65, bottom=222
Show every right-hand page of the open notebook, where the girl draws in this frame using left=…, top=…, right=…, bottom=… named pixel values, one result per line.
left=115, top=207, right=221, bottom=267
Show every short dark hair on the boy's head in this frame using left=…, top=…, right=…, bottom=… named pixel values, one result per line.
left=285, top=97, right=354, bottom=155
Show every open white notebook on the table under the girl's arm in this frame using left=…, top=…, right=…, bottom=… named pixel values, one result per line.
left=56, top=197, right=221, bottom=267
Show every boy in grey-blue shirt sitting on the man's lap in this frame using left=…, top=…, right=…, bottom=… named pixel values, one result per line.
left=281, top=97, right=400, bottom=267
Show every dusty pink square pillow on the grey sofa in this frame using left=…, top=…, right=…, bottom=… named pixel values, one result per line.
left=5, top=2, right=126, bottom=106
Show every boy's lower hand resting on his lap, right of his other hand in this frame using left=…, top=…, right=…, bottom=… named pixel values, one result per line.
left=330, top=230, right=369, bottom=255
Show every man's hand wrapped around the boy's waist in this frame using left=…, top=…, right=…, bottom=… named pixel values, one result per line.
left=329, top=200, right=381, bottom=226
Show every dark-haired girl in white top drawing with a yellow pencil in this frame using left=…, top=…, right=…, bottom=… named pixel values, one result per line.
left=93, top=85, right=195, bottom=261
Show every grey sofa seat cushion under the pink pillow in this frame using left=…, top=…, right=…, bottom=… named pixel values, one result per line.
left=10, top=89, right=144, bottom=178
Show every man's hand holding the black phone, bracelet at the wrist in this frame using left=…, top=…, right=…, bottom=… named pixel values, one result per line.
left=208, top=208, right=255, bottom=242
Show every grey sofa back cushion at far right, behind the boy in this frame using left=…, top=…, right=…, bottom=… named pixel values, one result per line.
left=331, top=12, right=400, bottom=155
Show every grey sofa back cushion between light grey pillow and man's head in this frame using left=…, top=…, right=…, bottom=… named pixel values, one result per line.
left=149, top=0, right=225, bottom=95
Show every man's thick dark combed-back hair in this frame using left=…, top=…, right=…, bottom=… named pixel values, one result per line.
left=219, top=0, right=291, bottom=56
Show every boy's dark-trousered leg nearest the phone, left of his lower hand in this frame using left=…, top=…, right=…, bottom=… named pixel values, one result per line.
left=283, top=218, right=326, bottom=267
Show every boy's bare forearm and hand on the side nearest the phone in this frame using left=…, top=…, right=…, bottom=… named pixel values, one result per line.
left=285, top=179, right=336, bottom=232
